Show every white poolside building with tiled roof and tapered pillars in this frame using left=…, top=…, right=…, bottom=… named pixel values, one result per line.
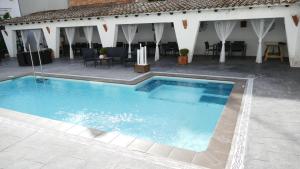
left=2, top=0, right=300, bottom=67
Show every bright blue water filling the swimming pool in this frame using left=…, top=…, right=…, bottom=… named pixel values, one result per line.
left=0, top=76, right=233, bottom=151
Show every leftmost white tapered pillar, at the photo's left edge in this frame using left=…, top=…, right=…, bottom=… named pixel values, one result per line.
left=1, top=30, right=17, bottom=57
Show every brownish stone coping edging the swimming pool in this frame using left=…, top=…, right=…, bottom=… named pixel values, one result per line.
left=0, top=72, right=247, bottom=169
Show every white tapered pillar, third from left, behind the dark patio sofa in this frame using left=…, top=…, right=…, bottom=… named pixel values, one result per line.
left=97, top=22, right=118, bottom=47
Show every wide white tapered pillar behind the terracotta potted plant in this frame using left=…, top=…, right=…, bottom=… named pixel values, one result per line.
left=173, top=18, right=200, bottom=63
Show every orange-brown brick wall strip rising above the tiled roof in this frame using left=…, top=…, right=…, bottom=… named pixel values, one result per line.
left=69, top=0, right=136, bottom=6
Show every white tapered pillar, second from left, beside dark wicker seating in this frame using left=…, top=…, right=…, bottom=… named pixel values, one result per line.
left=43, top=26, right=60, bottom=58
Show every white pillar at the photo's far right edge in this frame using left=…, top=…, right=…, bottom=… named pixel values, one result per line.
left=284, top=14, right=300, bottom=67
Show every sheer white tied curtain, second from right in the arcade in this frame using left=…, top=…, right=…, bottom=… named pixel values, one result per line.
left=215, top=21, right=236, bottom=63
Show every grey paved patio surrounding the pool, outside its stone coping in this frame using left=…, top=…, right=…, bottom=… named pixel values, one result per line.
left=0, top=58, right=300, bottom=169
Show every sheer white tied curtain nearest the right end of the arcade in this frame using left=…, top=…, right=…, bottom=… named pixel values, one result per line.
left=251, top=19, right=275, bottom=63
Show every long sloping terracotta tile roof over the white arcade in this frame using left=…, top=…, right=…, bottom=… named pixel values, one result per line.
left=3, top=0, right=298, bottom=24
